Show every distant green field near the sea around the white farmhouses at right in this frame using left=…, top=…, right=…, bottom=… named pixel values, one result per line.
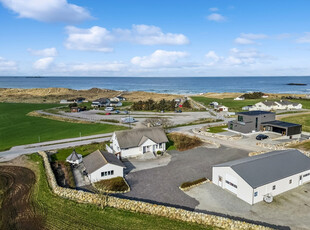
left=191, top=97, right=310, bottom=112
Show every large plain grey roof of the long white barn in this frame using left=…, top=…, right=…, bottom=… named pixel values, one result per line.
left=214, top=149, right=310, bottom=188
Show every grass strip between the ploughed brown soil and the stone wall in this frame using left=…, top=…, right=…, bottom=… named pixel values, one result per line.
left=29, top=154, right=213, bottom=230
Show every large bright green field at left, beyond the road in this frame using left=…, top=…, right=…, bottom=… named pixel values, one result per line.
left=0, top=103, right=125, bottom=151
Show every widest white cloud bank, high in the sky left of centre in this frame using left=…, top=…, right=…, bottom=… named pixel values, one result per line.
left=65, top=25, right=189, bottom=52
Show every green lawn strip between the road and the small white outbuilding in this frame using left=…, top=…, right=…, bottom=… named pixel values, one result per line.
left=52, top=142, right=108, bottom=161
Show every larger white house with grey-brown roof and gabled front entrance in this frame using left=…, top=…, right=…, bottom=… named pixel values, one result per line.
left=110, top=127, right=168, bottom=157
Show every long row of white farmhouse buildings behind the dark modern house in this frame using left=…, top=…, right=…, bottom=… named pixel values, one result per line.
left=249, top=100, right=302, bottom=111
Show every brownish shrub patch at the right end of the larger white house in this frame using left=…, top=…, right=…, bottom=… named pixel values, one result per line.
left=168, top=133, right=202, bottom=151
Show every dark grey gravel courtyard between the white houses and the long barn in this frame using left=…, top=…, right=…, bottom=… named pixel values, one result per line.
left=120, top=146, right=248, bottom=209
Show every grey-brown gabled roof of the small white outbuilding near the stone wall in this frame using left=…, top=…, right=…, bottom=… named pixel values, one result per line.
left=83, top=150, right=125, bottom=174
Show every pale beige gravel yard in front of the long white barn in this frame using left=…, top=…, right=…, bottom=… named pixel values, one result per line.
left=185, top=183, right=310, bottom=230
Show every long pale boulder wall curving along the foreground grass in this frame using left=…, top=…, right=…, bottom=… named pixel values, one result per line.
left=39, top=151, right=270, bottom=230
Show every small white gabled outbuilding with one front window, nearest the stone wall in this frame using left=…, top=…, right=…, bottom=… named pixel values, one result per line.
left=83, top=150, right=125, bottom=183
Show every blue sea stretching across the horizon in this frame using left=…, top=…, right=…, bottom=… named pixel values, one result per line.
left=0, top=76, right=310, bottom=95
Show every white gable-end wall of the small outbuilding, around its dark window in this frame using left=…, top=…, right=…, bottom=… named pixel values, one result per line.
left=88, top=164, right=124, bottom=183
